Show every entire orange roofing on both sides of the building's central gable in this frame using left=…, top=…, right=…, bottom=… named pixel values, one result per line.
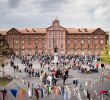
left=0, top=28, right=109, bottom=35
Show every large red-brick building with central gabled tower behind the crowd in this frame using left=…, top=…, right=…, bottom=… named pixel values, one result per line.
left=0, top=20, right=108, bottom=55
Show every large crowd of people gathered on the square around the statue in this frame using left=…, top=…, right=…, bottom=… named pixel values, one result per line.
left=5, top=55, right=106, bottom=99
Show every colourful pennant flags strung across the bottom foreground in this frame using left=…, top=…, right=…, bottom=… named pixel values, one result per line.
left=0, top=70, right=109, bottom=100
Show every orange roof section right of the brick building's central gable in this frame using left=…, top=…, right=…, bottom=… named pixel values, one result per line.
left=66, top=28, right=95, bottom=33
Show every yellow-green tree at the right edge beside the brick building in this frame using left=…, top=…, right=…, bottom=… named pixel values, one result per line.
left=101, top=44, right=110, bottom=64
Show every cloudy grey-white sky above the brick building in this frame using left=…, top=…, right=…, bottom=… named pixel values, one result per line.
left=0, top=0, right=110, bottom=31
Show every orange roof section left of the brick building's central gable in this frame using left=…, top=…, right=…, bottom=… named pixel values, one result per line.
left=17, top=28, right=46, bottom=33
